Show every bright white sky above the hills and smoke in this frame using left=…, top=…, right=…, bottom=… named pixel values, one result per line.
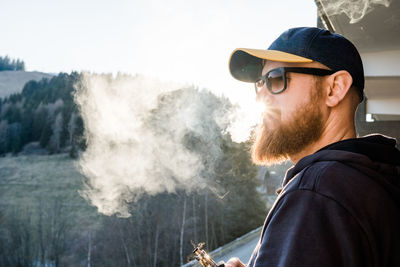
left=0, top=0, right=317, bottom=102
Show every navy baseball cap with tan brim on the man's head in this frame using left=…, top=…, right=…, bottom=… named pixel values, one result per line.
left=229, top=27, right=364, bottom=99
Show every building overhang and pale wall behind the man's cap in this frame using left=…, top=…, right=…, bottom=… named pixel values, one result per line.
left=315, top=0, right=400, bottom=120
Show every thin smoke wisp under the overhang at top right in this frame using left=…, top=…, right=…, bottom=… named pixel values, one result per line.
left=321, top=0, right=391, bottom=23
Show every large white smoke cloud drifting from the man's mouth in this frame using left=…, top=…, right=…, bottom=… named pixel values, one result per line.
left=75, top=73, right=258, bottom=217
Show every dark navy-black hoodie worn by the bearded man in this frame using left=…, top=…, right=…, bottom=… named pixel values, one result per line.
left=249, top=135, right=400, bottom=267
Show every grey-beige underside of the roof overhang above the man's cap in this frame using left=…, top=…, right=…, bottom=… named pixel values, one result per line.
left=316, top=0, right=400, bottom=53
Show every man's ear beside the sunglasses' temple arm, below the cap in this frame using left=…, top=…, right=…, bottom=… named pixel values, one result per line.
left=326, top=70, right=353, bottom=107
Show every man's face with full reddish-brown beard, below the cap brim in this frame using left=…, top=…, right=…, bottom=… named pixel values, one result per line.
left=252, top=61, right=324, bottom=165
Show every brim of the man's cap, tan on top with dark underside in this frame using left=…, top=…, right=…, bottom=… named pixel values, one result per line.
left=229, top=48, right=313, bottom=82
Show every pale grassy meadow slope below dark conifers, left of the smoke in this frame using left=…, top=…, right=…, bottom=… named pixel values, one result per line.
left=0, top=154, right=97, bottom=224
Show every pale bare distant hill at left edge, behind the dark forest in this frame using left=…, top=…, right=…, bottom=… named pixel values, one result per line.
left=0, top=71, right=54, bottom=98
